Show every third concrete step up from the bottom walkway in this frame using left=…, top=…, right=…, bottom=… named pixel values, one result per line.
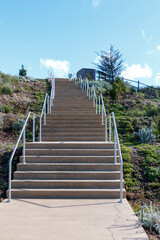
left=14, top=171, right=120, bottom=180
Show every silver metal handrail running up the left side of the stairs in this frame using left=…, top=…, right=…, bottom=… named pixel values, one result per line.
left=8, top=76, right=55, bottom=202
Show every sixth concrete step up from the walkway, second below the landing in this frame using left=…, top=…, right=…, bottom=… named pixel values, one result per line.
left=26, top=149, right=118, bottom=156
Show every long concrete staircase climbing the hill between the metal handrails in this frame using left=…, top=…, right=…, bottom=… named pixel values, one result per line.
left=8, top=79, right=125, bottom=199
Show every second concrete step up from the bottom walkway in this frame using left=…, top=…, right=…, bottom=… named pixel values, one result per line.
left=12, top=179, right=124, bottom=189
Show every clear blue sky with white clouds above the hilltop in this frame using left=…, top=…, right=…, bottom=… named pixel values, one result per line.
left=0, top=0, right=160, bottom=86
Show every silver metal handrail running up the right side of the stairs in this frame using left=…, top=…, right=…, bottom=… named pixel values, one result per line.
left=74, top=78, right=123, bottom=202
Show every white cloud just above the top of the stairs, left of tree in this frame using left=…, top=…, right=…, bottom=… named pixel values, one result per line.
left=40, top=58, right=70, bottom=78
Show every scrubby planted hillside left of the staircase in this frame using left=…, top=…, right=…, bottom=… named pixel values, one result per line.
left=0, top=73, right=50, bottom=199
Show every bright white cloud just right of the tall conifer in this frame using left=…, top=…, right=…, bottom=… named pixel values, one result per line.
left=122, top=64, right=152, bottom=79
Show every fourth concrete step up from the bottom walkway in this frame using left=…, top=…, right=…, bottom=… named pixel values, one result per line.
left=17, top=163, right=120, bottom=171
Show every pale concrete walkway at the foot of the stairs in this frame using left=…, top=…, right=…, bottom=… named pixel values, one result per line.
left=0, top=199, right=148, bottom=240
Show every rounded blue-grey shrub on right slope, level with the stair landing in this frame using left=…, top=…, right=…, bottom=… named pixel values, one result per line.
left=135, top=127, right=156, bottom=143
